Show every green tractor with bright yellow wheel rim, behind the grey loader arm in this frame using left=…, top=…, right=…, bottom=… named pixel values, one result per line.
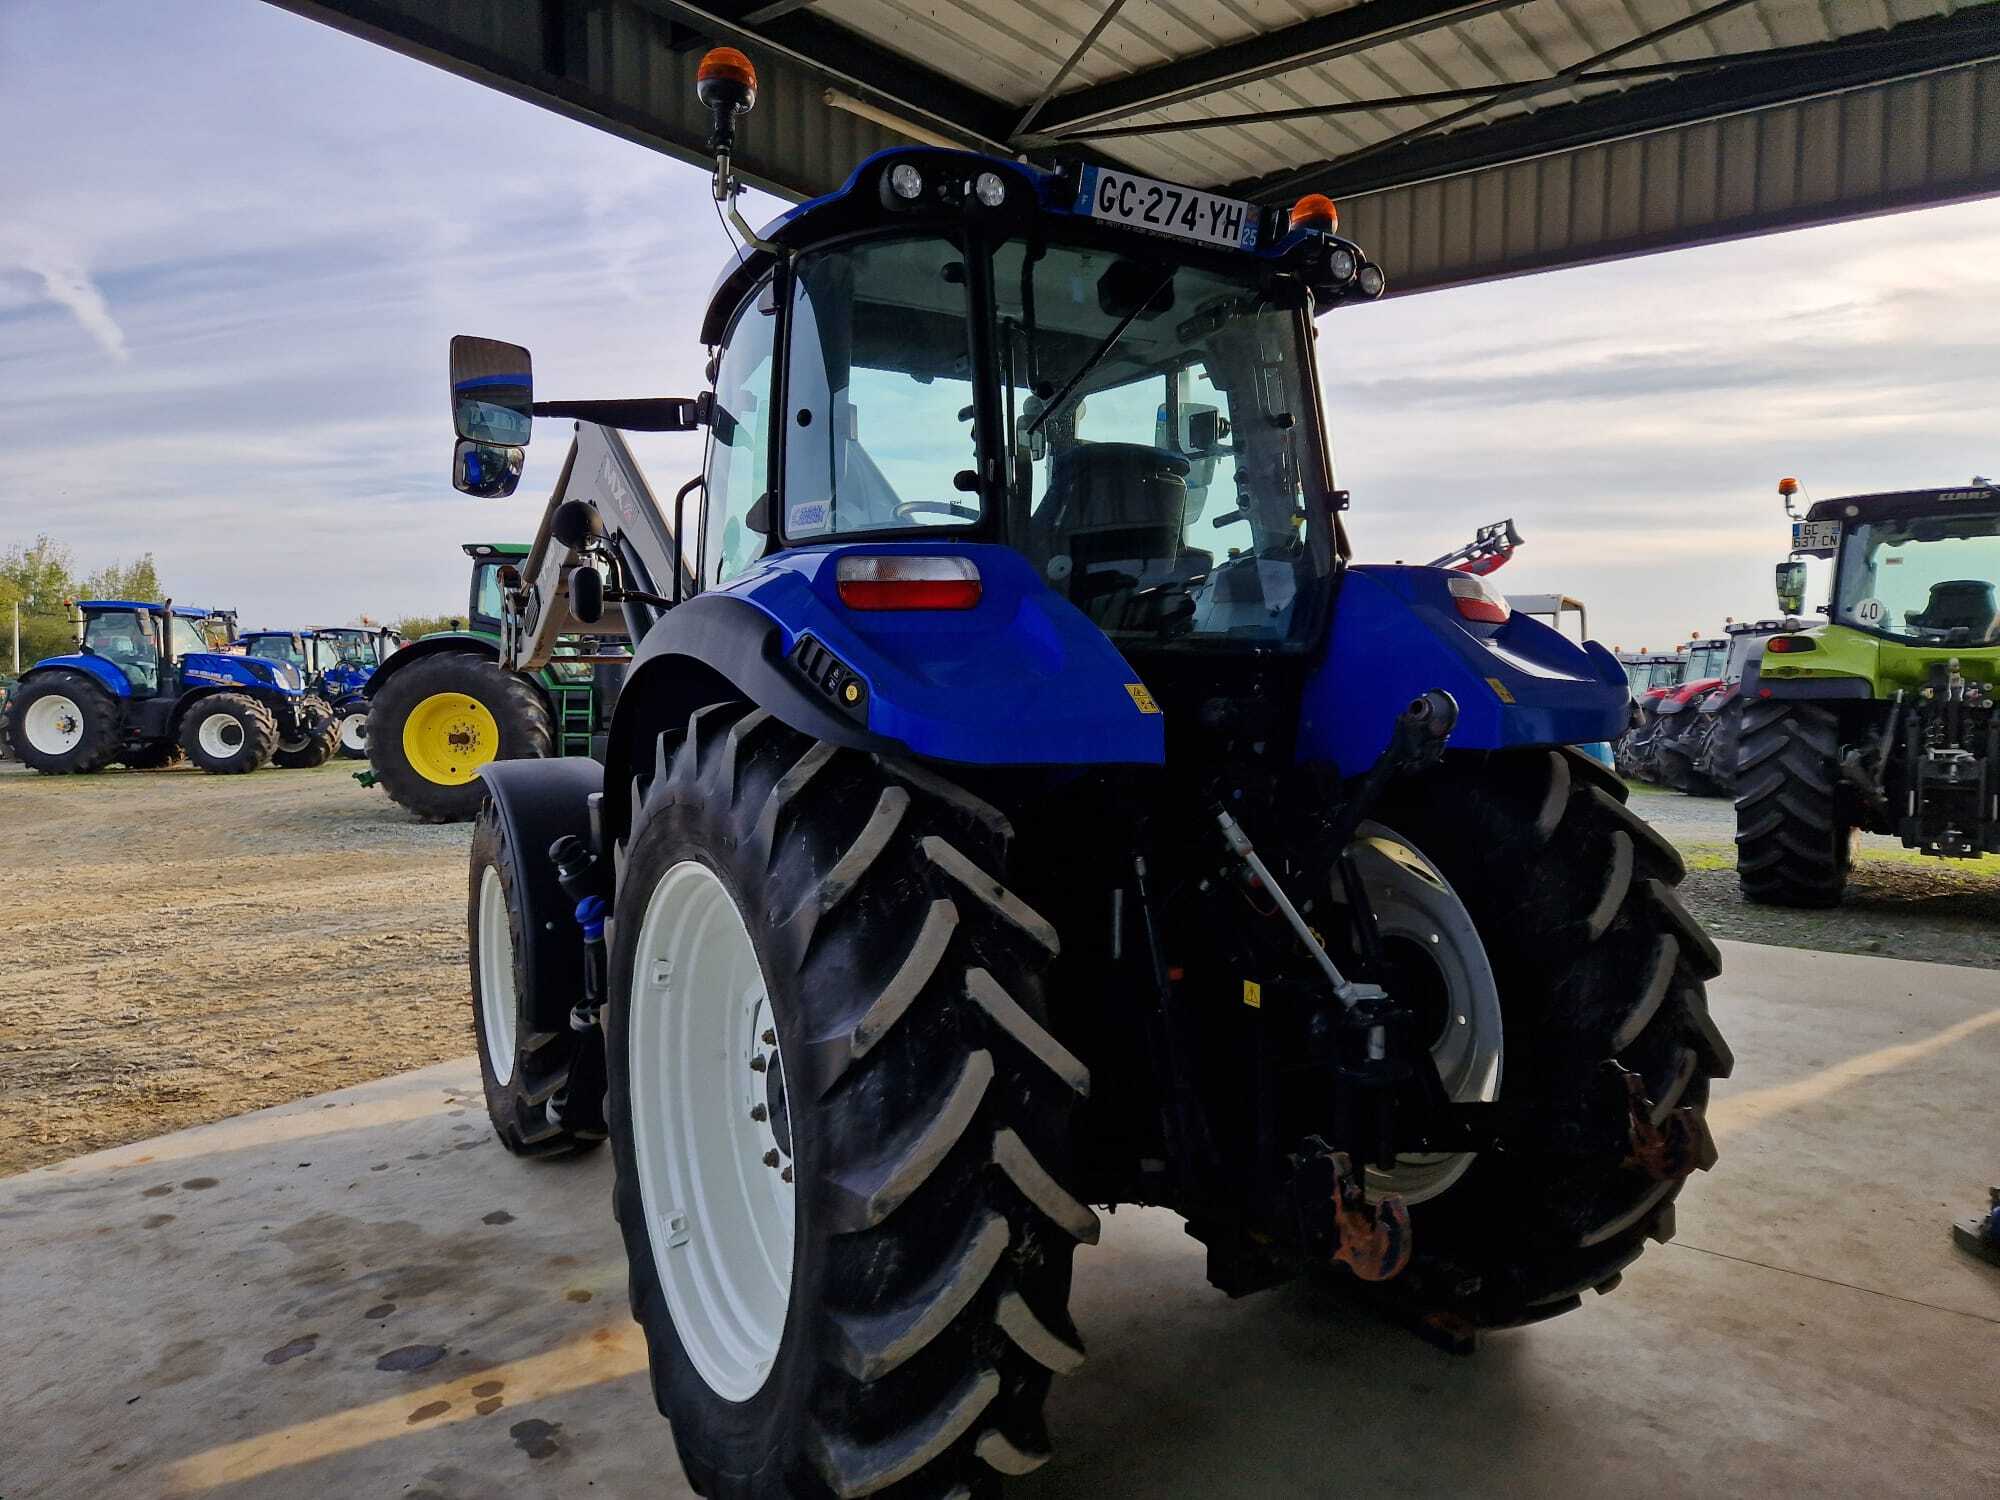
left=362, top=542, right=626, bottom=822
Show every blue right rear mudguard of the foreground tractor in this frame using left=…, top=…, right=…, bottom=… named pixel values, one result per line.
left=1298, top=564, right=1630, bottom=776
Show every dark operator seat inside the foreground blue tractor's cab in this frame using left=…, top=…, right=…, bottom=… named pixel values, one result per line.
left=1028, top=442, right=1210, bottom=628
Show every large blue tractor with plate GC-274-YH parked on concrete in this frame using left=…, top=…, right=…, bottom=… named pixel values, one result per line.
left=452, top=52, right=1730, bottom=1498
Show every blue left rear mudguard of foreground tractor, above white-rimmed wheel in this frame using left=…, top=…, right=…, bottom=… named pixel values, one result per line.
left=612, top=542, right=1168, bottom=766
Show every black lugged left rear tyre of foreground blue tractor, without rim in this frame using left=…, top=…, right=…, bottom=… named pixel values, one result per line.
left=608, top=704, right=1098, bottom=1500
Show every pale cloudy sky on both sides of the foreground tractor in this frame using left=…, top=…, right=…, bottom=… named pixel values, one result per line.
left=0, top=0, right=2000, bottom=644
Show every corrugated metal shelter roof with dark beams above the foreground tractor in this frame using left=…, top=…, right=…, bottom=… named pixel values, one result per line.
left=274, top=0, right=2000, bottom=286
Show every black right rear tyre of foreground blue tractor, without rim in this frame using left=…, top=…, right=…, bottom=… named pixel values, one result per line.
left=1380, top=748, right=1734, bottom=1328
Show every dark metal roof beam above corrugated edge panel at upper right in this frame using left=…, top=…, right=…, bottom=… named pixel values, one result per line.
left=1224, top=6, right=2000, bottom=198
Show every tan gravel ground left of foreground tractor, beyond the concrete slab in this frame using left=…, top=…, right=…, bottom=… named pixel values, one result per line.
left=0, top=760, right=472, bottom=1174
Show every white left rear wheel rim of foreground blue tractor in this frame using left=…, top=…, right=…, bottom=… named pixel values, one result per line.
left=626, top=860, right=798, bottom=1402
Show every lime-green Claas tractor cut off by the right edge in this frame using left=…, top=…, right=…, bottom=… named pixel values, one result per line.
left=1736, top=478, right=2000, bottom=906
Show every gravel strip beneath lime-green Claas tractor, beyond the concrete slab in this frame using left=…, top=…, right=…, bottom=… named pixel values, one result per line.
left=1628, top=782, right=2000, bottom=968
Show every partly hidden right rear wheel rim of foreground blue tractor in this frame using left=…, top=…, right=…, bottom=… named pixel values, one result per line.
left=1334, top=824, right=1504, bottom=1204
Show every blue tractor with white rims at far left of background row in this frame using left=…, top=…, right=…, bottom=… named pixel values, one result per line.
left=6, top=600, right=326, bottom=776
